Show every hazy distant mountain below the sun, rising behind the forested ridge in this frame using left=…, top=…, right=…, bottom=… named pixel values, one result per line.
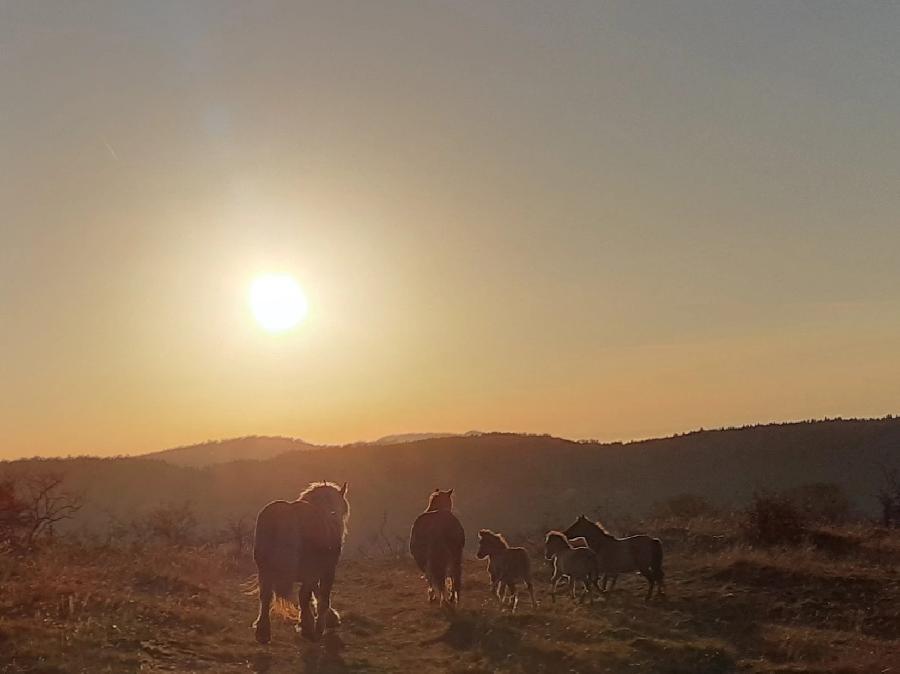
left=140, top=435, right=320, bottom=467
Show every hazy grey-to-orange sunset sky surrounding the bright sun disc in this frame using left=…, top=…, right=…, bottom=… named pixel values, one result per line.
left=0, top=0, right=900, bottom=457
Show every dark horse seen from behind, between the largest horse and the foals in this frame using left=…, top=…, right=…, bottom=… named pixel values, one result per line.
left=409, top=489, right=466, bottom=606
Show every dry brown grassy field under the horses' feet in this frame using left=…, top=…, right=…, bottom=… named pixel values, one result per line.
left=0, top=520, right=900, bottom=674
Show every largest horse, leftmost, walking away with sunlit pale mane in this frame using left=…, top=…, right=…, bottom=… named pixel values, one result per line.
left=253, top=482, right=350, bottom=644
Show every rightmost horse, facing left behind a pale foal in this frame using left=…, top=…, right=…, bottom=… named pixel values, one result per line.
left=563, top=515, right=665, bottom=600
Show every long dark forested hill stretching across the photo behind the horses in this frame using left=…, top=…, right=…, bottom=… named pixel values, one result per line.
left=0, top=418, right=900, bottom=548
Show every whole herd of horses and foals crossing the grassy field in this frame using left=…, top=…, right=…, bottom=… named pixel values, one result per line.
left=253, top=482, right=664, bottom=644
